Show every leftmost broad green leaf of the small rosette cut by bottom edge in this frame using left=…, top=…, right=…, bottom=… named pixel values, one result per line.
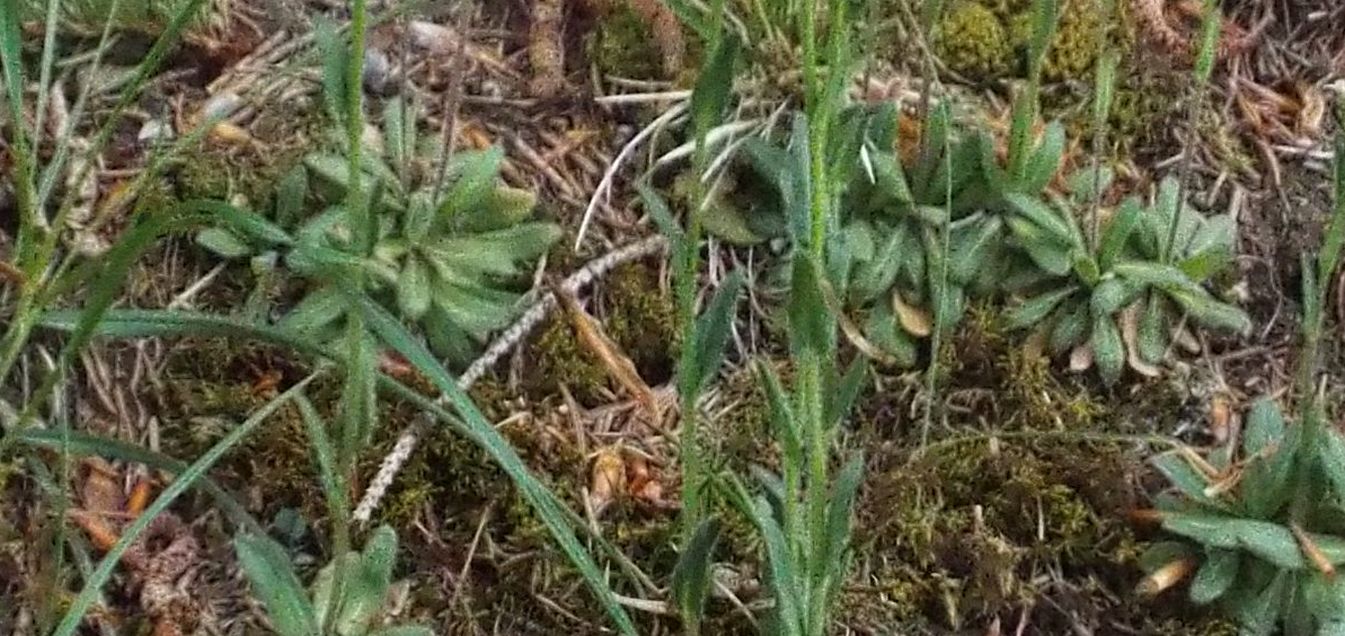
left=234, top=534, right=317, bottom=636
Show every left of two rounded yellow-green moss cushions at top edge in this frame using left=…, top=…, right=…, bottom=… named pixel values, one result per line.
left=935, top=1, right=1014, bottom=81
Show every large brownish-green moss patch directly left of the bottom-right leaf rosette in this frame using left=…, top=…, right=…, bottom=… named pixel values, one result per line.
left=849, top=441, right=1162, bottom=633
